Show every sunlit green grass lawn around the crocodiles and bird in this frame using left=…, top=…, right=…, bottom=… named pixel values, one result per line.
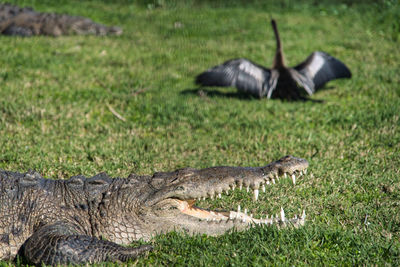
left=0, top=0, right=400, bottom=266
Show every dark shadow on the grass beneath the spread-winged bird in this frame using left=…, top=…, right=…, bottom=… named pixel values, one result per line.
left=180, top=87, right=325, bottom=104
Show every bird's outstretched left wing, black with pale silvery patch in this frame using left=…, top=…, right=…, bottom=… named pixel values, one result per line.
left=196, top=58, right=276, bottom=97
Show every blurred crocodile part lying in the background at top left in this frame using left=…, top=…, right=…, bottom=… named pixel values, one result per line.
left=0, top=4, right=122, bottom=36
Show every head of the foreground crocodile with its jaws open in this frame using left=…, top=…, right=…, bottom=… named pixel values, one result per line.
left=140, top=156, right=308, bottom=239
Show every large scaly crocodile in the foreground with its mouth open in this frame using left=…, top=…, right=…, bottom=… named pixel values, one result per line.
left=0, top=156, right=308, bottom=265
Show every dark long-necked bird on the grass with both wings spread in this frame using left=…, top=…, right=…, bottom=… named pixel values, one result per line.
left=196, top=19, right=351, bottom=100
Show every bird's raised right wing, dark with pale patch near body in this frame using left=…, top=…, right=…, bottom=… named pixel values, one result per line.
left=294, top=51, right=351, bottom=92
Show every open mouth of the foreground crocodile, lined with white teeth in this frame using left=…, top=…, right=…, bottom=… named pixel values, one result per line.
left=171, top=169, right=307, bottom=227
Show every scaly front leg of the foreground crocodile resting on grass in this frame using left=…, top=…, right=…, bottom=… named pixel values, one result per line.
left=21, top=222, right=152, bottom=265
